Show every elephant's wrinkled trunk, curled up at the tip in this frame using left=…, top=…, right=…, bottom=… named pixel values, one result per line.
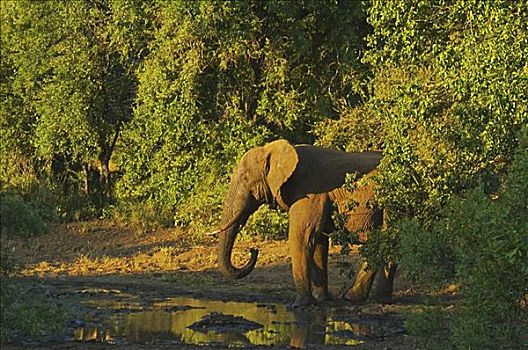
left=218, top=182, right=258, bottom=279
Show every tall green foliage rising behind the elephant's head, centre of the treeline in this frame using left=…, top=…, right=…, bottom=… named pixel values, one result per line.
left=117, top=0, right=367, bottom=228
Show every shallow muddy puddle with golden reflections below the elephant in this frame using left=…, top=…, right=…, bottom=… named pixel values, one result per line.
left=75, top=298, right=374, bottom=347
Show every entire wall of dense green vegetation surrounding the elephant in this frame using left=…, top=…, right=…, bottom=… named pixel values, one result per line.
left=0, top=0, right=528, bottom=348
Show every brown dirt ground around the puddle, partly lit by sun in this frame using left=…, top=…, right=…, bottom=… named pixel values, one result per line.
left=1, top=221, right=452, bottom=349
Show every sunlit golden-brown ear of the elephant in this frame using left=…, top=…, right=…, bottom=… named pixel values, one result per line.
left=264, top=140, right=299, bottom=198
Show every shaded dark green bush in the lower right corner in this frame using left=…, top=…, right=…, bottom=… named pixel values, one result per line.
left=446, top=141, right=528, bottom=349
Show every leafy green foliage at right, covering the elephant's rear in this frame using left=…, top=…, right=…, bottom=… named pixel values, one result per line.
left=318, top=6, right=528, bottom=348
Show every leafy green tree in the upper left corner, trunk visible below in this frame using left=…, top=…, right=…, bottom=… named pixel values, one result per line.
left=2, top=0, right=152, bottom=212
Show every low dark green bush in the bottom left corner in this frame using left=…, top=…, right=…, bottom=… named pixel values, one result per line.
left=0, top=277, right=67, bottom=343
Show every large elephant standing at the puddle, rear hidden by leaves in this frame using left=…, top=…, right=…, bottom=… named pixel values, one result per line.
left=213, top=139, right=393, bottom=306
